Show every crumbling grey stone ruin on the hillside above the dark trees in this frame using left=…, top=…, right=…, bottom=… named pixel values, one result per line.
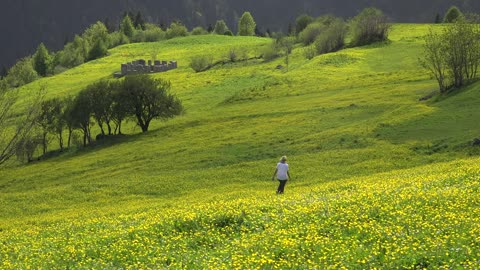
left=114, top=59, right=177, bottom=78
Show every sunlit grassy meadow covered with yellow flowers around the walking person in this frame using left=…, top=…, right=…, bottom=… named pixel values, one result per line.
left=0, top=24, right=480, bottom=269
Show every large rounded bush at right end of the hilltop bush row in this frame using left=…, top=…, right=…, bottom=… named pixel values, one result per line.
left=351, top=8, right=390, bottom=46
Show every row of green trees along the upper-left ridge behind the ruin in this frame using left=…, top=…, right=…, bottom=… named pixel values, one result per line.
left=1, top=12, right=256, bottom=90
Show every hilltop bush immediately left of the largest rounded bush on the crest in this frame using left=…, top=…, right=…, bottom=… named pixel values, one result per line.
left=314, top=19, right=347, bottom=54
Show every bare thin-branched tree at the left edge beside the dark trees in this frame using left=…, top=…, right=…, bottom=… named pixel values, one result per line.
left=0, top=82, right=45, bottom=165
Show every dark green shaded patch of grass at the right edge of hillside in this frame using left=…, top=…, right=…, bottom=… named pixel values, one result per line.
left=374, top=84, right=480, bottom=155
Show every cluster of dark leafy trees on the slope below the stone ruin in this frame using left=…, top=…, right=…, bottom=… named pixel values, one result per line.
left=16, top=75, right=183, bottom=161
